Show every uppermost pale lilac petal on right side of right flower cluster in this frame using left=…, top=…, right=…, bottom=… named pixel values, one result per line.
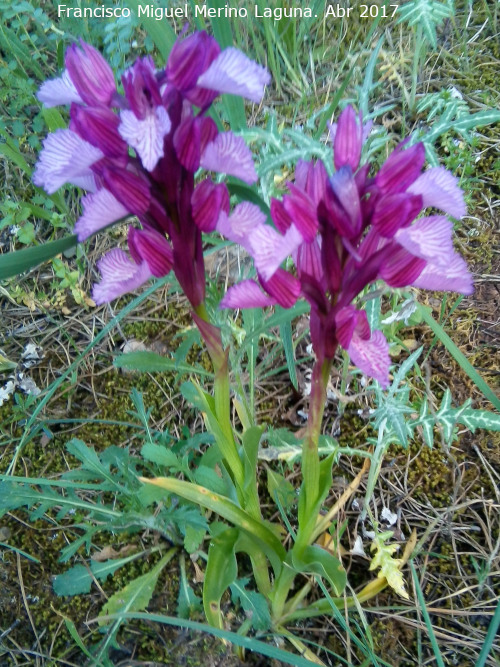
left=407, top=167, right=467, bottom=218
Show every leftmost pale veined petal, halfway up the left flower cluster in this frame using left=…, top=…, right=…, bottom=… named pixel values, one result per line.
left=33, top=130, right=104, bottom=195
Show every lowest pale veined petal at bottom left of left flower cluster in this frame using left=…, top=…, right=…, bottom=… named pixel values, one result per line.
left=92, top=248, right=152, bottom=305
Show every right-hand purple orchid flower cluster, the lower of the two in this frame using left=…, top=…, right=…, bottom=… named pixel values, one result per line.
left=217, top=107, right=473, bottom=386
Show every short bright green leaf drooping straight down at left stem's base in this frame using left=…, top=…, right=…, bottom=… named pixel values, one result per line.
left=203, top=528, right=239, bottom=629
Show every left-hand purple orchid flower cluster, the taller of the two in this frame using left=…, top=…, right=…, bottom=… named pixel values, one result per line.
left=33, top=32, right=270, bottom=308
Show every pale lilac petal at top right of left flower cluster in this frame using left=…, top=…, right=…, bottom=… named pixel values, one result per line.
left=197, top=47, right=271, bottom=102
